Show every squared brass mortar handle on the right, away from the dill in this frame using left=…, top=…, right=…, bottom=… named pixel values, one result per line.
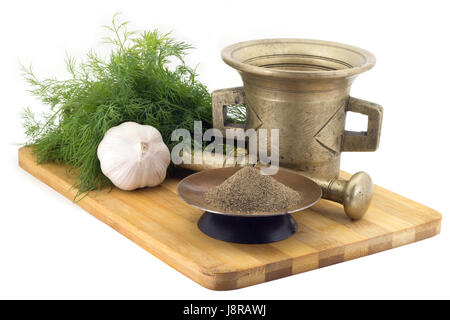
left=342, top=97, right=383, bottom=151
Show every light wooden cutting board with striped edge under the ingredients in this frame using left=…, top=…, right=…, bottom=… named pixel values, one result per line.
left=19, top=148, right=441, bottom=290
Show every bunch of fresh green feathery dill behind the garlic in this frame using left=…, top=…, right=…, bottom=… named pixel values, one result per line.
left=22, top=16, right=212, bottom=196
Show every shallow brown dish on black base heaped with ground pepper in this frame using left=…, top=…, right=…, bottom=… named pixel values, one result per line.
left=177, top=166, right=322, bottom=243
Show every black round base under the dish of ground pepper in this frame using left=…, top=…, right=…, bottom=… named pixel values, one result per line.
left=198, top=212, right=297, bottom=244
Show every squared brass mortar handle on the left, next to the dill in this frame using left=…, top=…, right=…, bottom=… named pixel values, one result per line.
left=211, top=87, right=245, bottom=136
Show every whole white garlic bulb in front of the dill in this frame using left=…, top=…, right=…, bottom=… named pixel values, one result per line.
left=97, top=122, right=170, bottom=190
